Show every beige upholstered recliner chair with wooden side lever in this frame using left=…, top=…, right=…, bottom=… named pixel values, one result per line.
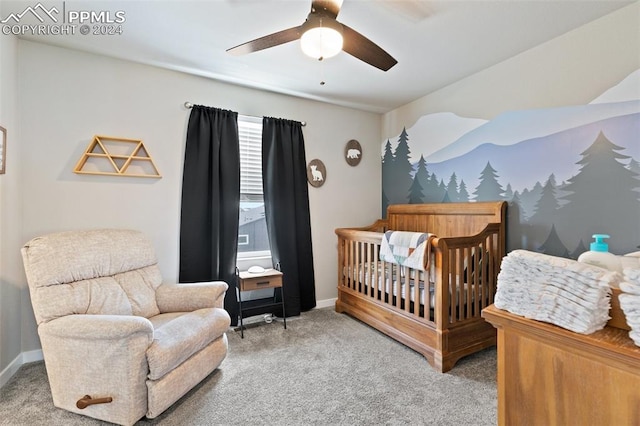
left=22, top=229, right=230, bottom=425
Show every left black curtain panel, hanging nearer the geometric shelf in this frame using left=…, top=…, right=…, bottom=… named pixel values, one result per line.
left=180, top=105, right=240, bottom=325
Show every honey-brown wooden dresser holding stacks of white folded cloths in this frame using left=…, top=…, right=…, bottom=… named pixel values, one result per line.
left=482, top=305, right=640, bottom=426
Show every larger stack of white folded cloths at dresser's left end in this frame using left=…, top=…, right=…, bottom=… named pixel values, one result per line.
left=495, top=250, right=620, bottom=334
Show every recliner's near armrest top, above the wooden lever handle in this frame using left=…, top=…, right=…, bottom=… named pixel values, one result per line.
left=39, top=315, right=153, bottom=344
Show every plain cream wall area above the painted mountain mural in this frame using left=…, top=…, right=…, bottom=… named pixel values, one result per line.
left=381, top=2, right=640, bottom=136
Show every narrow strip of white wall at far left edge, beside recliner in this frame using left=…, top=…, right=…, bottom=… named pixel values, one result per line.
left=0, top=35, right=29, bottom=386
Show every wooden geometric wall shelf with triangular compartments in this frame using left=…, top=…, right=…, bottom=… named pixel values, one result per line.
left=73, top=135, right=162, bottom=178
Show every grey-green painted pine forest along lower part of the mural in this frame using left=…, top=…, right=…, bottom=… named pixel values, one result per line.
left=382, top=122, right=640, bottom=258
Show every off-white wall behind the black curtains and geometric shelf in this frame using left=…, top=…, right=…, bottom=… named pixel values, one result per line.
left=15, top=40, right=381, bottom=356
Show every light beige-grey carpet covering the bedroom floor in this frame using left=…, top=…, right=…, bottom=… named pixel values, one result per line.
left=0, top=308, right=497, bottom=426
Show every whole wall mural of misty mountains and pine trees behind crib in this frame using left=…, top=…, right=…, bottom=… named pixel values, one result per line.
left=382, top=70, right=640, bottom=259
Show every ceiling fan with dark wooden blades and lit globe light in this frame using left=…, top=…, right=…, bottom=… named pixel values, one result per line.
left=227, top=0, right=398, bottom=71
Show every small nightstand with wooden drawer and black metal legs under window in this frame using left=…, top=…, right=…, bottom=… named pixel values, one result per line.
left=237, top=269, right=287, bottom=339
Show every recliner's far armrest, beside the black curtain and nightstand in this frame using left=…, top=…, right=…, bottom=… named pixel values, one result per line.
left=156, top=281, right=229, bottom=313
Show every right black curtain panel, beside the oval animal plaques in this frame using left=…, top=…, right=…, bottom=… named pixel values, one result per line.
left=262, top=117, right=316, bottom=316
